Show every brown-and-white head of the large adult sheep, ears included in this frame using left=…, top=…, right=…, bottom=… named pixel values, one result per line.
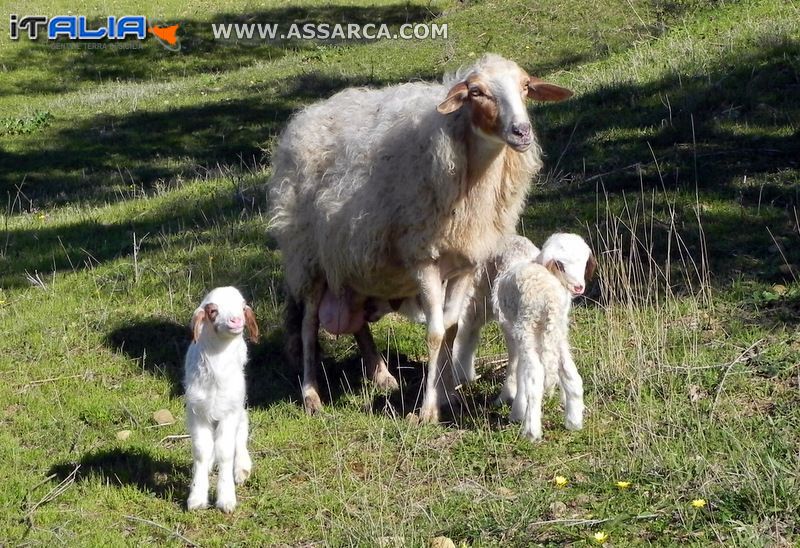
left=437, top=54, right=572, bottom=152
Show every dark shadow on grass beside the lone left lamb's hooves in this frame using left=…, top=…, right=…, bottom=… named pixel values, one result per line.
left=48, top=448, right=191, bottom=501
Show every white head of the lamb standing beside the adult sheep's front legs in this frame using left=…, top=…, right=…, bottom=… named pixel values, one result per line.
left=536, top=233, right=597, bottom=296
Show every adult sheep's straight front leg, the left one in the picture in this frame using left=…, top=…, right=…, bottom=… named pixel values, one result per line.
left=417, top=264, right=445, bottom=423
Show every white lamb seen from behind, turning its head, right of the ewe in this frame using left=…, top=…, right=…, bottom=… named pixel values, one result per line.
left=493, top=233, right=596, bottom=440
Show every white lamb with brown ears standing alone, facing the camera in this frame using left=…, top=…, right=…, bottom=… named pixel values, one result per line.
left=184, top=287, right=258, bottom=512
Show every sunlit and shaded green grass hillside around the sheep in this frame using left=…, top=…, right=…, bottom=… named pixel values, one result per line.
left=0, top=0, right=800, bottom=546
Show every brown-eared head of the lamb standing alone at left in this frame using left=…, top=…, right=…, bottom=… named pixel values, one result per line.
left=192, top=287, right=258, bottom=341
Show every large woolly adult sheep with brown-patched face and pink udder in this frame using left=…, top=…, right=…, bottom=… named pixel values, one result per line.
left=269, top=54, right=572, bottom=422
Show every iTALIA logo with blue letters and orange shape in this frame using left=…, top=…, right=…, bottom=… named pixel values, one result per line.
left=8, top=14, right=181, bottom=51
